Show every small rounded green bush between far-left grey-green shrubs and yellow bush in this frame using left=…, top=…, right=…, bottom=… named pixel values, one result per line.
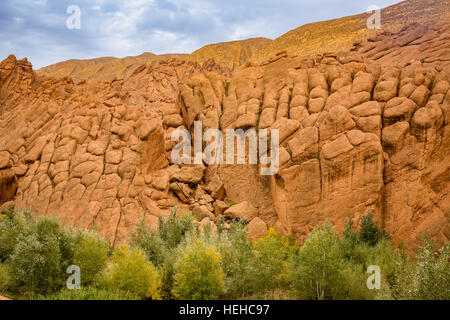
left=73, top=233, right=109, bottom=284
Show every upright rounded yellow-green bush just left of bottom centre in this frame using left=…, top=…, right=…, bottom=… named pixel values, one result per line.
left=172, top=238, right=224, bottom=300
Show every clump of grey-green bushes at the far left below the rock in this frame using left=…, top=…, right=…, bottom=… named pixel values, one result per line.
left=0, top=211, right=109, bottom=298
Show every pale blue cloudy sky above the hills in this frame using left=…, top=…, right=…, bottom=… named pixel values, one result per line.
left=0, top=0, right=399, bottom=69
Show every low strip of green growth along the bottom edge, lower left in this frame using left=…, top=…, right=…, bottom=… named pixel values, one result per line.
left=34, top=287, right=138, bottom=301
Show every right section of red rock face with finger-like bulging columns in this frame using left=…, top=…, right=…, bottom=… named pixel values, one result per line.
left=173, top=25, right=450, bottom=248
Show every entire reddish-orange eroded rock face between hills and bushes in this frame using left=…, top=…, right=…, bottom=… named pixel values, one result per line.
left=0, top=21, right=450, bottom=250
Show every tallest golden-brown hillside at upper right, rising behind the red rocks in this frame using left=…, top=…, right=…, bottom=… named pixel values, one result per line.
left=250, top=0, right=450, bottom=64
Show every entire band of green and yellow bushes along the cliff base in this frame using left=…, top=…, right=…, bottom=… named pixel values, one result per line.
left=0, top=210, right=450, bottom=300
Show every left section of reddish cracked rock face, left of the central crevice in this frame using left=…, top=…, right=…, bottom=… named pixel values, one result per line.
left=0, top=56, right=230, bottom=244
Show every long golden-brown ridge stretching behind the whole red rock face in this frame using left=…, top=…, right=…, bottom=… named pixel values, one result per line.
left=37, top=0, right=450, bottom=82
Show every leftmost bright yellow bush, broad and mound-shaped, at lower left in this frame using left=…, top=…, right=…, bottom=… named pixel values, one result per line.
left=100, top=246, right=161, bottom=299
